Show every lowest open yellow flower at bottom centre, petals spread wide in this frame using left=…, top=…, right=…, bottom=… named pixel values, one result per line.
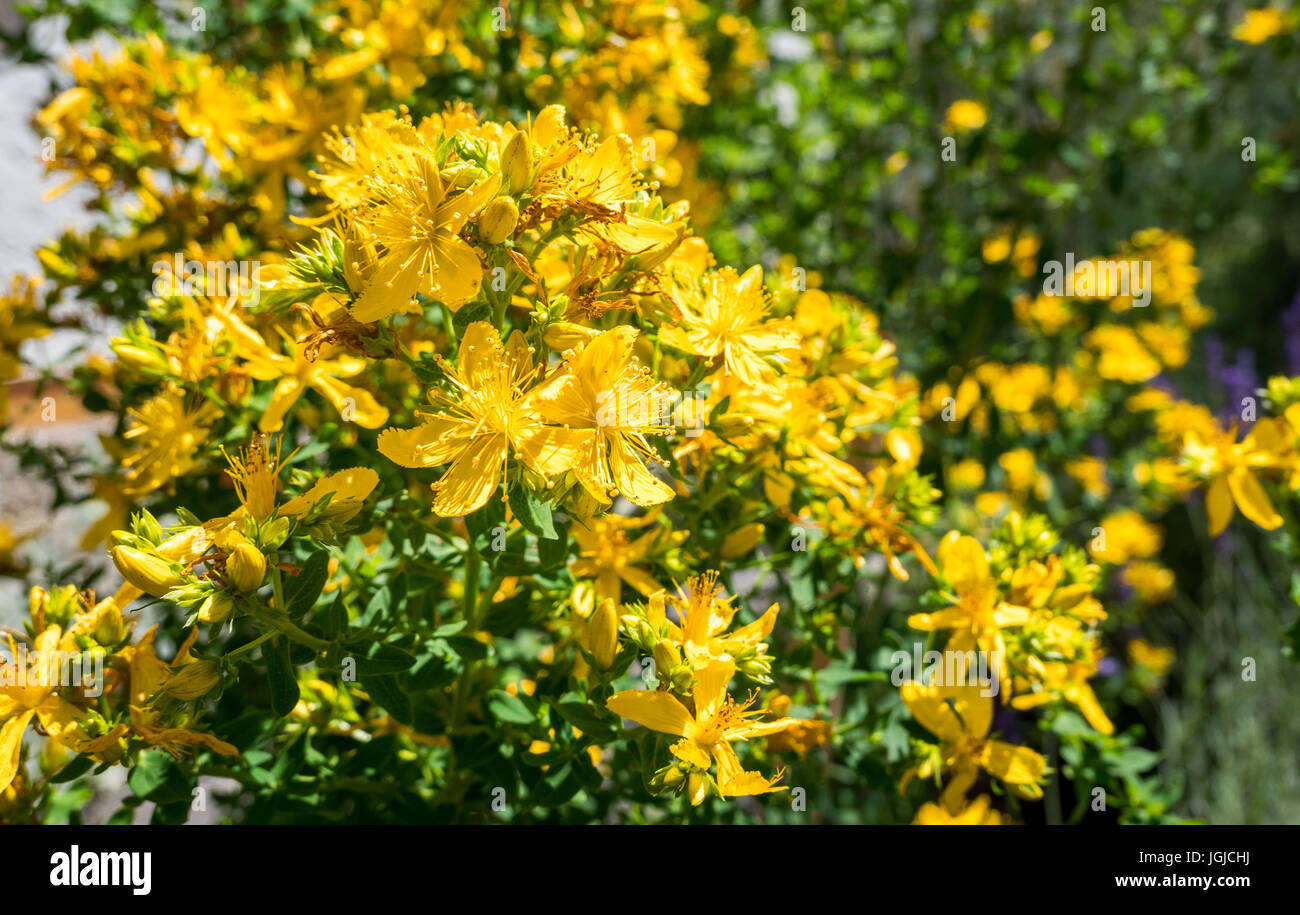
left=605, top=660, right=790, bottom=805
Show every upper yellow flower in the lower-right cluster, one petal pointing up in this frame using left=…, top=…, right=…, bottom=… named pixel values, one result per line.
left=907, top=530, right=1030, bottom=697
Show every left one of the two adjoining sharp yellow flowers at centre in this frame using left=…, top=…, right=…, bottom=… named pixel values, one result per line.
left=380, top=321, right=563, bottom=517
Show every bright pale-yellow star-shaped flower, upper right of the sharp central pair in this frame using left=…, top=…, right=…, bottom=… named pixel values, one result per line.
left=659, top=265, right=800, bottom=387
